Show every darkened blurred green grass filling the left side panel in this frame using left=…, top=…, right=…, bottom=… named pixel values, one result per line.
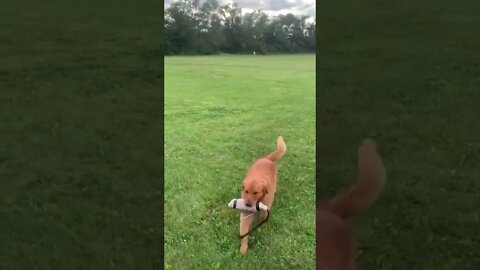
left=0, top=0, right=163, bottom=270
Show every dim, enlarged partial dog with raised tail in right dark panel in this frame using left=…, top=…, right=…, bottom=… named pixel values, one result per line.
left=316, top=139, right=386, bottom=270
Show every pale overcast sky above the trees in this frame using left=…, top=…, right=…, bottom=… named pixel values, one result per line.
left=165, top=0, right=315, bottom=17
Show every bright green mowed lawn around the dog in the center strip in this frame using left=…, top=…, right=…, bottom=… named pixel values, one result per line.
left=165, top=55, right=315, bottom=269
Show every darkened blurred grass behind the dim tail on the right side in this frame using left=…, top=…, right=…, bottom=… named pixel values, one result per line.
left=317, top=0, right=480, bottom=270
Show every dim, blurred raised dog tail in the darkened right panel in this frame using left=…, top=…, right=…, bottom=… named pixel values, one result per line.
left=328, top=139, right=386, bottom=220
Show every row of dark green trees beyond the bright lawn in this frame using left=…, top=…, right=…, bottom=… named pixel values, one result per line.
left=164, top=0, right=315, bottom=55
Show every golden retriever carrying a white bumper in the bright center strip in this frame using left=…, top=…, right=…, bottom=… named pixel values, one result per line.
left=240, top=137, right=287, bottom=255
